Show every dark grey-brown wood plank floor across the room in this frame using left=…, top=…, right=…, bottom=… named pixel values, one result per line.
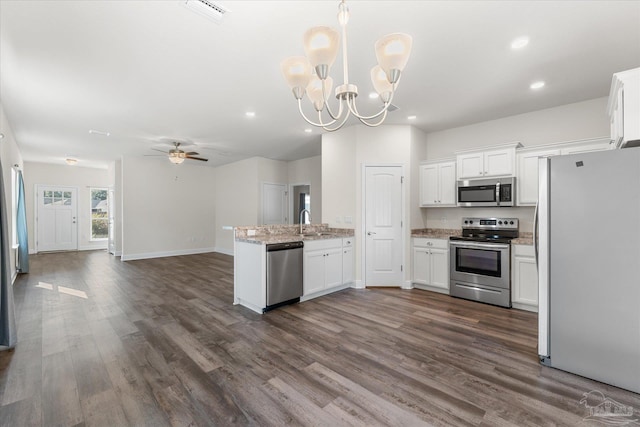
left=0, top=251, right=640, bottom=426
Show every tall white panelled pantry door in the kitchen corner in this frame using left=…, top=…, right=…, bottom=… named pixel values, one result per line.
left=364, top=166, right=403, bottom=286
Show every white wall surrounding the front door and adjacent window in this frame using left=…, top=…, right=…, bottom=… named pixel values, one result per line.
left=24, top=162, right=109, bottom=253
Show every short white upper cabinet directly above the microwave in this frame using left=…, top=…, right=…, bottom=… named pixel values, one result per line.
left=456, top=143, right=520, bottom=179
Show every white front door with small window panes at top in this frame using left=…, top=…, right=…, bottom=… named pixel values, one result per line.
left=36, top=185, right=78, bottom=252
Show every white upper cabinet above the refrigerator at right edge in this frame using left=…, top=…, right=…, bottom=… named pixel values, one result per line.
left=608, top=68, right=640, bottom=147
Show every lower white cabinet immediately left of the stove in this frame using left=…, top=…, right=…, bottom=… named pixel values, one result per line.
left=411, top=237, right=449, bottom=293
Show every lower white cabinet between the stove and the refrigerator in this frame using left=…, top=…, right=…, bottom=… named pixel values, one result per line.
left=511, top=245, right=538, bottom=312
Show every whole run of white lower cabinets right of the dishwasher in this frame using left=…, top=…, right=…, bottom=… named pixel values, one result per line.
left=303, top=238, right=353, bottom=299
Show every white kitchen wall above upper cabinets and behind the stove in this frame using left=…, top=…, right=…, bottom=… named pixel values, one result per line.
left=424, top=97, right=609, bottom=232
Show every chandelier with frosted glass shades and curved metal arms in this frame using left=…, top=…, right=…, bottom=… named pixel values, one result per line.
left=282, top=0, right=412, bottom=131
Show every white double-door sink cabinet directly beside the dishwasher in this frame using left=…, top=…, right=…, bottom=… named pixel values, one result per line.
left=303, top=239, right=343, bottom=296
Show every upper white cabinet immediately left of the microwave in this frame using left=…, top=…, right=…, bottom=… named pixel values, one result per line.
left=420, top=161, right=456, bottom=207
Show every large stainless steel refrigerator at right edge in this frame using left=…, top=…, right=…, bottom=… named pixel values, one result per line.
left=534, top=147, right=640, bottom=393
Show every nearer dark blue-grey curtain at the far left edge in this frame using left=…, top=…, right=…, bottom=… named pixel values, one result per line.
left=0, top=160, right=17, bottom=350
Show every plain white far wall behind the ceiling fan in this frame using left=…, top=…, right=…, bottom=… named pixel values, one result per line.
left=121, top=157, right=216, bottom=260
